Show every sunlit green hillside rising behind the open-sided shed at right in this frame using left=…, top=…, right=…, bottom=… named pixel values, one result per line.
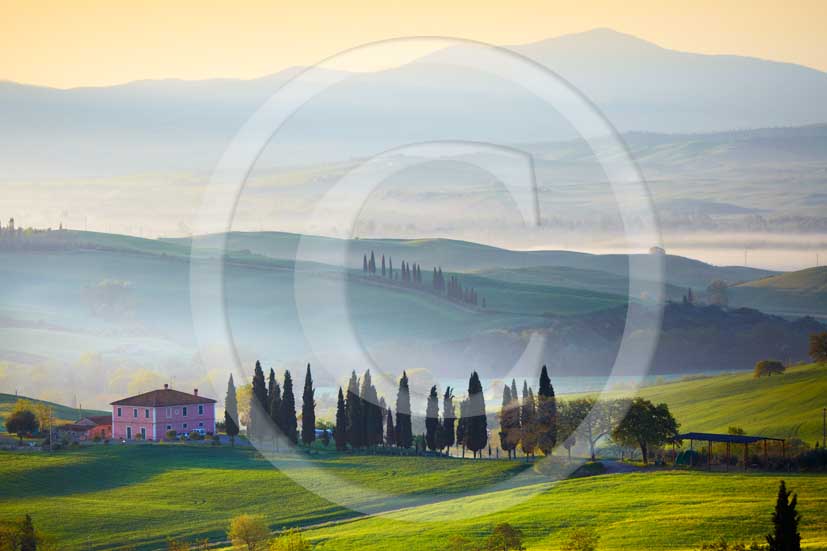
left=639, top=365, right=827, bottom=445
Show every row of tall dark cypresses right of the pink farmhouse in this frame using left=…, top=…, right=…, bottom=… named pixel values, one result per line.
left=225, top=362, right=558, bottom=457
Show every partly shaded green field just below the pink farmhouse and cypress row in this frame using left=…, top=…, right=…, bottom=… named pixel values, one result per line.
left=0, top=445, right=524, bottom=550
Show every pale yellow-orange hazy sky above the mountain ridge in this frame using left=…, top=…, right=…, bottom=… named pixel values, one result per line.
left=0, top=0, right=827, bottom=87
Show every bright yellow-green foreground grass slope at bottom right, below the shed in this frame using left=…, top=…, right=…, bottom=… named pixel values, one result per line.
left=306, top=472, right=827, bottom=551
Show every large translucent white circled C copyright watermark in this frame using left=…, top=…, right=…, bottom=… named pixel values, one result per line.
left=191, top=37, right=664, bottom=521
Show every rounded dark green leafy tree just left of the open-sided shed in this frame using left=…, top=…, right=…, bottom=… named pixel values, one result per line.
left=612, top=398, right=678, bottom=463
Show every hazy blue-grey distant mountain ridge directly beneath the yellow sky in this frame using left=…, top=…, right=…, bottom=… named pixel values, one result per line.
left=0, top=29, right=827, bottom=178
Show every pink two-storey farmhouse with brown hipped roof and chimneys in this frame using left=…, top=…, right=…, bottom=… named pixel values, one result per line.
left=111, top=385, right=215, bottom=440
